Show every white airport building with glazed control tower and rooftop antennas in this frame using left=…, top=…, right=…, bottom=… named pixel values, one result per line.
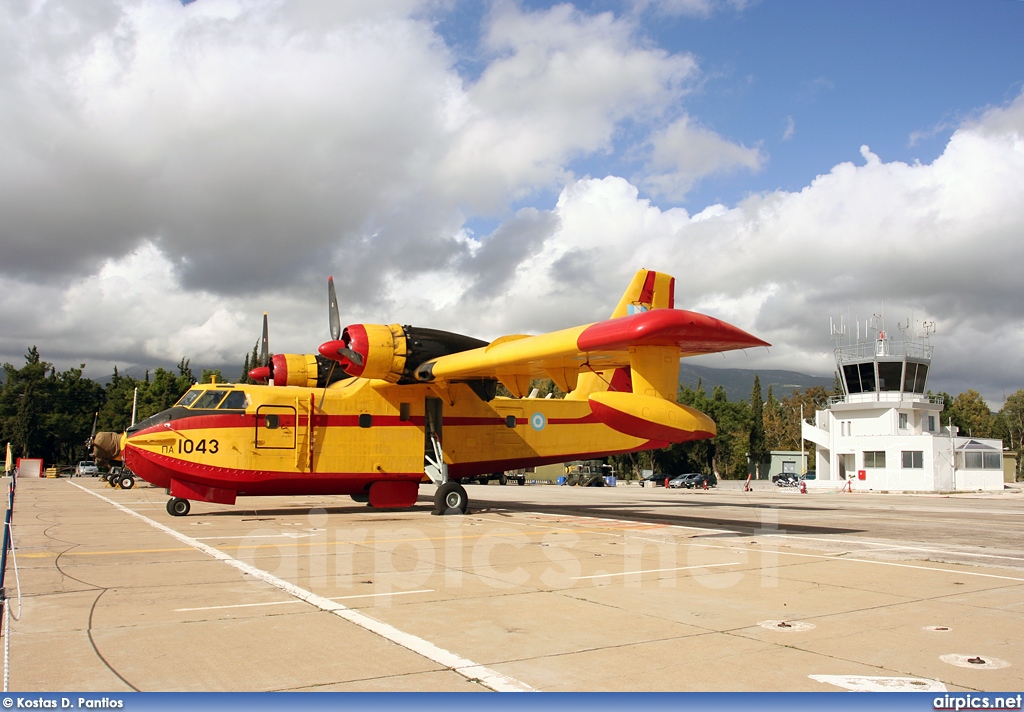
left=803, top=317, right=1004, bottom=492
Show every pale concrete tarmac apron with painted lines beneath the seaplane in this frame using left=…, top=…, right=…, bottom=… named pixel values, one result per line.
left=5, top=478, right=1024, bottom=693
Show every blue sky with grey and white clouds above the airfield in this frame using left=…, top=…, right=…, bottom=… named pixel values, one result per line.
left=0, top=0, right=1024, bottom=408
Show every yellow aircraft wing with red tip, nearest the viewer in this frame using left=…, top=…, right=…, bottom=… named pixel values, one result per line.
left=416, top=308, right=769, bottom=395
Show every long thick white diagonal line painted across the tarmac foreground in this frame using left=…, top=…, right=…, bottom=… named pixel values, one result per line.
left=69, top=481, right=532, bottom=693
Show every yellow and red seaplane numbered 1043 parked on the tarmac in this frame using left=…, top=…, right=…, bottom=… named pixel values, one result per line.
left=121, top=269, right=768, bottom=516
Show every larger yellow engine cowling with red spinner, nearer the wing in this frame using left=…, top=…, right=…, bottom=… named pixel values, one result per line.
left=319, top=324, right=409, bottom=383
